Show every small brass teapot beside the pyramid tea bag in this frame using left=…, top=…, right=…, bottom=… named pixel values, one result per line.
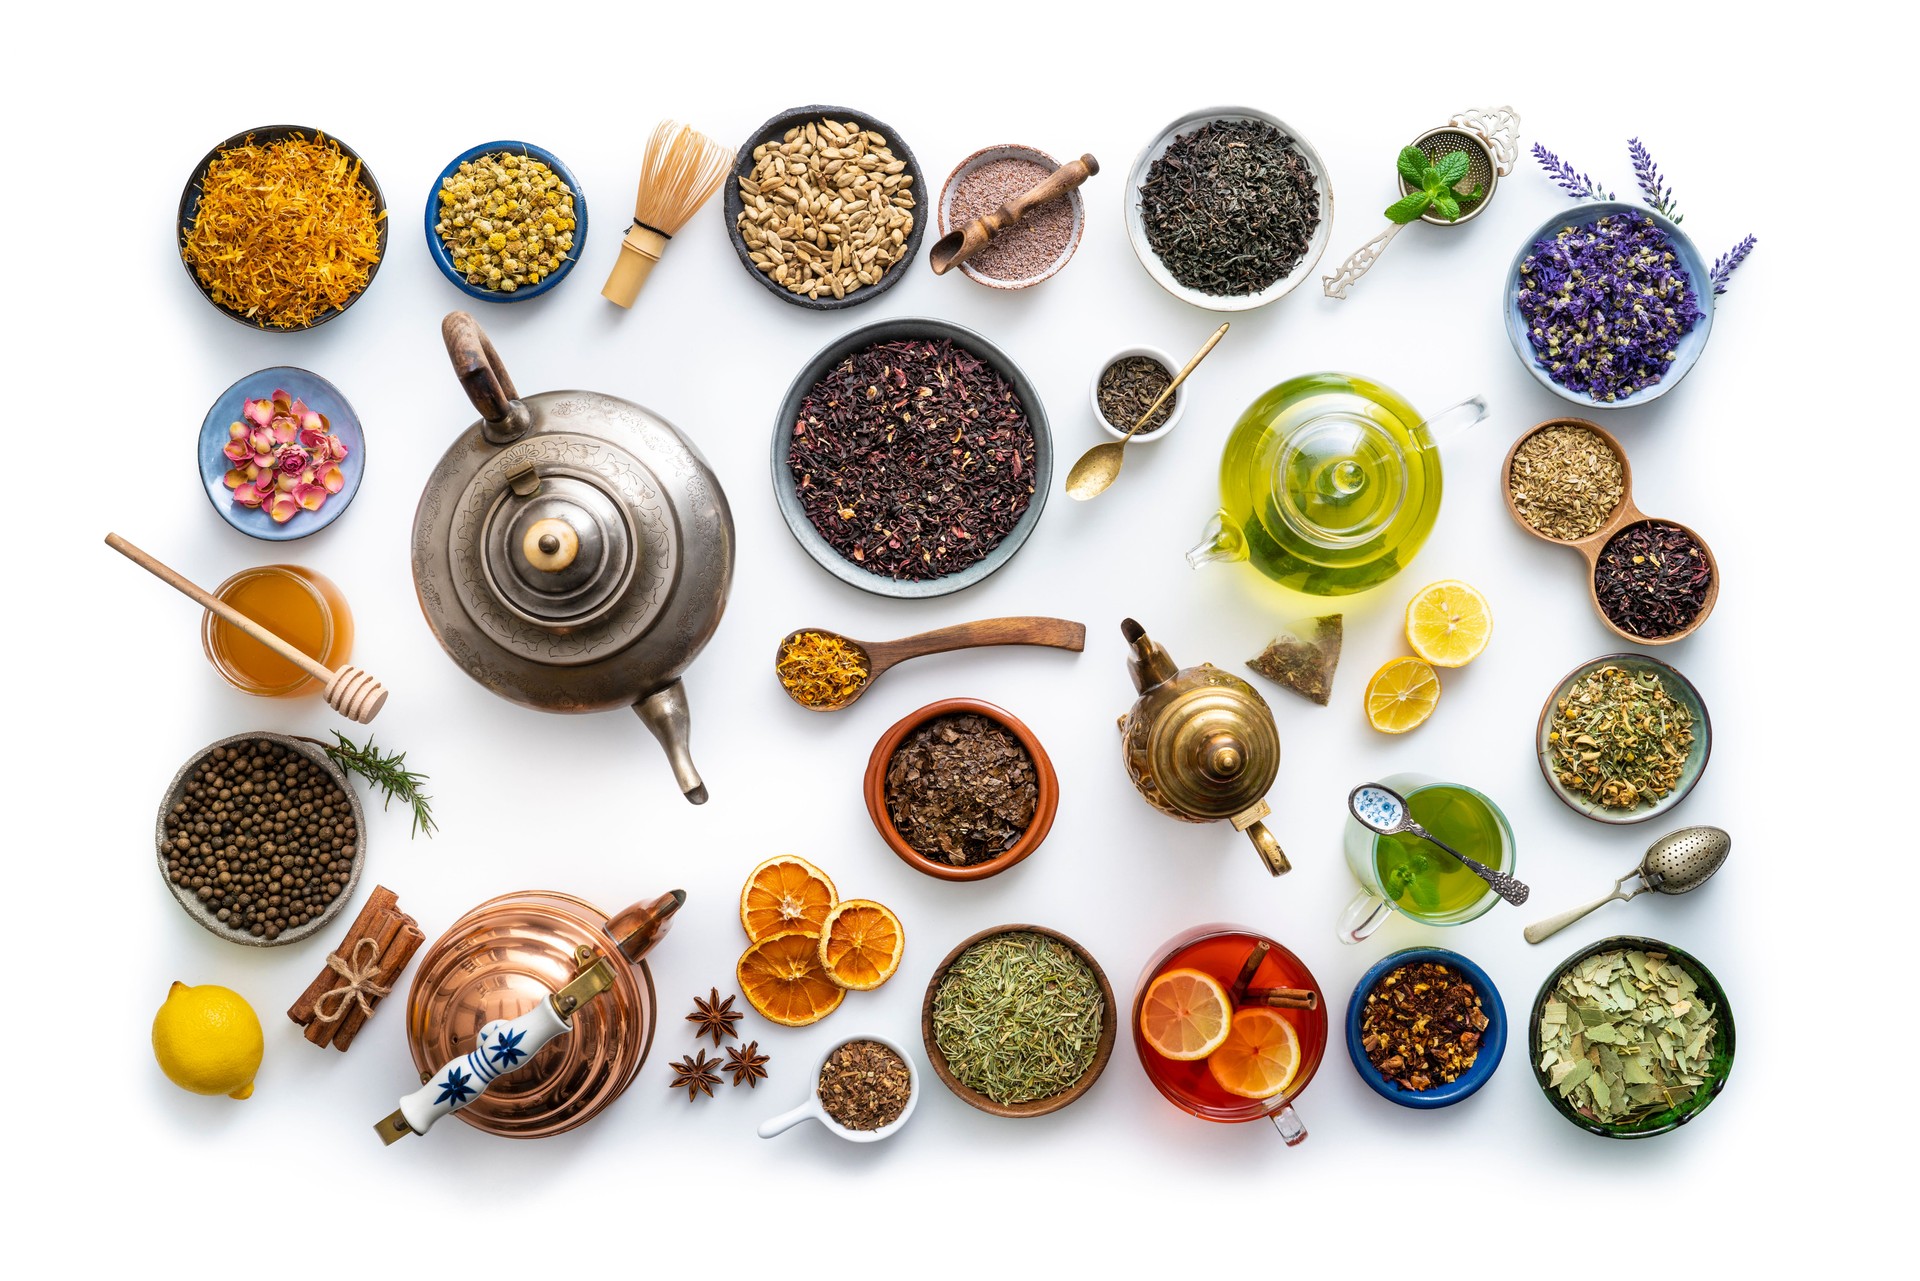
left=1119, top=618, right=1292, bottom=876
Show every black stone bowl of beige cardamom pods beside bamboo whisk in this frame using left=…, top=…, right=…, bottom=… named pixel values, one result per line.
left=720, top=106, right=927, bottom=311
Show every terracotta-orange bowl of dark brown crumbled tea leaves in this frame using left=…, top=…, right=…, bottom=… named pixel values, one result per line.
left=862, top=699, right=1060, bottom=882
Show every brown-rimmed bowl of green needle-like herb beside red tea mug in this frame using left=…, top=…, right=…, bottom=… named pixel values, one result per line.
left=920, top=926, right=1119, bottom=1118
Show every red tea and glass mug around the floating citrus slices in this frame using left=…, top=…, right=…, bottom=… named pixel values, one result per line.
left=1133, top=924, right=1327, bottom=1147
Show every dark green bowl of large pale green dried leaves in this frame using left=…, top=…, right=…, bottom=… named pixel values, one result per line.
left=1526, top=933, right=1734, bottom=1139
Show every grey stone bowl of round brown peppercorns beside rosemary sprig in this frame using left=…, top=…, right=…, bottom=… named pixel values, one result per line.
left=154, top=730, right=367, bottom=947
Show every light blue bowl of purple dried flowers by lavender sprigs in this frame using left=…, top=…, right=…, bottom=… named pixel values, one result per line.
left=1501, top=200, right=1713, bottom=409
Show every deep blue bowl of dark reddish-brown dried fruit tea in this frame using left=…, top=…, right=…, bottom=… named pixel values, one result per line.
left=1346, top=947, right=1507, bottom=1110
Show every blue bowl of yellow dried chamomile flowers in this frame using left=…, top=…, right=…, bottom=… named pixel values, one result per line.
left=426, top=142, right=588, bottom=302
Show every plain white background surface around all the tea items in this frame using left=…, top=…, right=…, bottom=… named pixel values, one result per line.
left=0, top=4, right=1914, bottom=1277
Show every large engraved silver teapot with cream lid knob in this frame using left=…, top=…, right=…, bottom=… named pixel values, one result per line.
left=413, top=311, right=733, bottom=805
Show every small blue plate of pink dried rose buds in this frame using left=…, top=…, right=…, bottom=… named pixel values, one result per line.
left=200, top=365, right=367, bottom=542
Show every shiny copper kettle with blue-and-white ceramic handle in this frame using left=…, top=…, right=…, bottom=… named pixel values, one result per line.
left=376, top=889, right=687, bottom=1143
